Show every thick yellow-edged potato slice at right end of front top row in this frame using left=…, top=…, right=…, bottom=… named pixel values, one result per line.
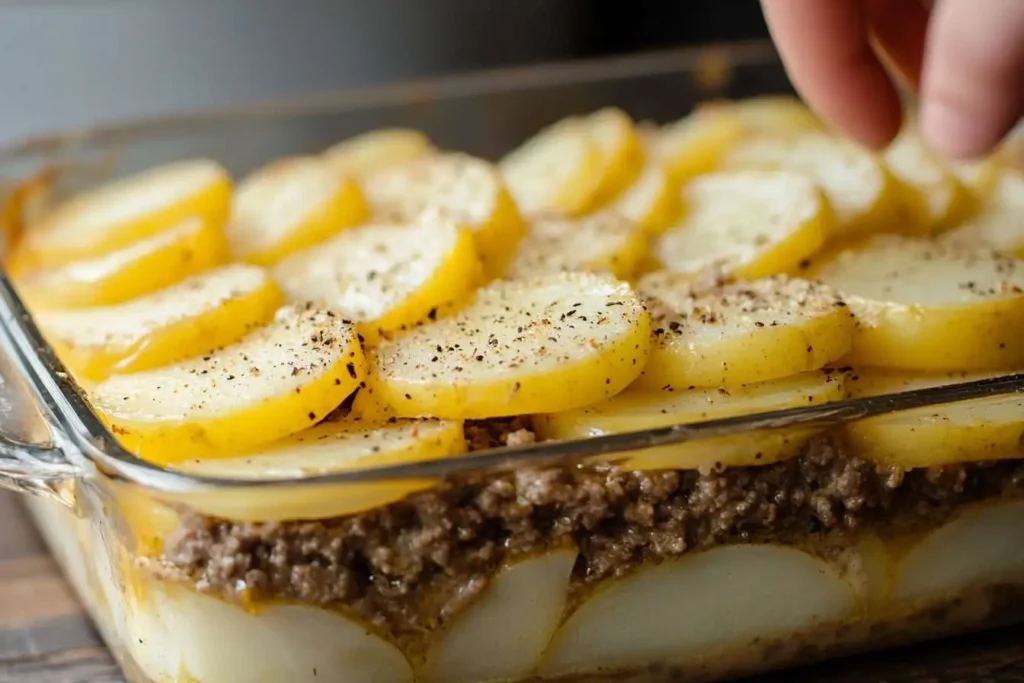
left=811, top=236, right=1024, bottom=372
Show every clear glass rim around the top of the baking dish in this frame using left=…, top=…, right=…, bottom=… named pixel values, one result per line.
left=0, top=41, right=1024, bottom=494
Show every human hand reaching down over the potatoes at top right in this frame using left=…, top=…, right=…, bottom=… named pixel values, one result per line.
left=761, top=0, right=1024, bottom=158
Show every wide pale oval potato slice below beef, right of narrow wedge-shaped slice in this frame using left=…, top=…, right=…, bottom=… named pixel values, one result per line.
left=540, top=545, right=860, bottom=676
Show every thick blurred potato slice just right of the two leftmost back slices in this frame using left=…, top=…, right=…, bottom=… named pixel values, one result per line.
left=225, top=157, right=369, bottom=265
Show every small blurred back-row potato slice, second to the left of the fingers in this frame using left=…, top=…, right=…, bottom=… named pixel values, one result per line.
left=647, top=106, right=746, bottom=183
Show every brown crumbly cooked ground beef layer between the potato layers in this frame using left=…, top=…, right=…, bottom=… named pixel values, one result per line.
left=156, top=428, right=1024, bottom=638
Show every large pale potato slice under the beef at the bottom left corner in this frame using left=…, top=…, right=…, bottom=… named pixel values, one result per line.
left=124, top=579, right=414, bottom=683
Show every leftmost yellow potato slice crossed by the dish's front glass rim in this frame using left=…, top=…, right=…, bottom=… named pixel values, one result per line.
left=175, top=420, right=466, bottom=520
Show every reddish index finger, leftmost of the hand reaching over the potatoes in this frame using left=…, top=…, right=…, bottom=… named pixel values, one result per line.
left=761, top=0, right=901, bottom=147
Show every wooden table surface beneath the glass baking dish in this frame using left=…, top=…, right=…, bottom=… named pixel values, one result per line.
left=0, top=492, right=1024, bottom=683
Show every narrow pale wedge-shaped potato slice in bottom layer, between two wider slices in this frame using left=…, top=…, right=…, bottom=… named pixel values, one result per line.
left=425, top=550, right=577, bottom=683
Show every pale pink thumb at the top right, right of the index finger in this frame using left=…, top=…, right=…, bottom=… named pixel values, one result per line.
left=921, top=0, right=1024, bottom=158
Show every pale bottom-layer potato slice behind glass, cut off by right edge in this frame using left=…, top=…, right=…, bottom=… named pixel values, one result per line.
left=891, top=501, right=1024, bottom=606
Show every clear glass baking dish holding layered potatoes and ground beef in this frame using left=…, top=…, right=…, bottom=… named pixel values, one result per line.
left=0, top=38, right=1024, bottom=683
